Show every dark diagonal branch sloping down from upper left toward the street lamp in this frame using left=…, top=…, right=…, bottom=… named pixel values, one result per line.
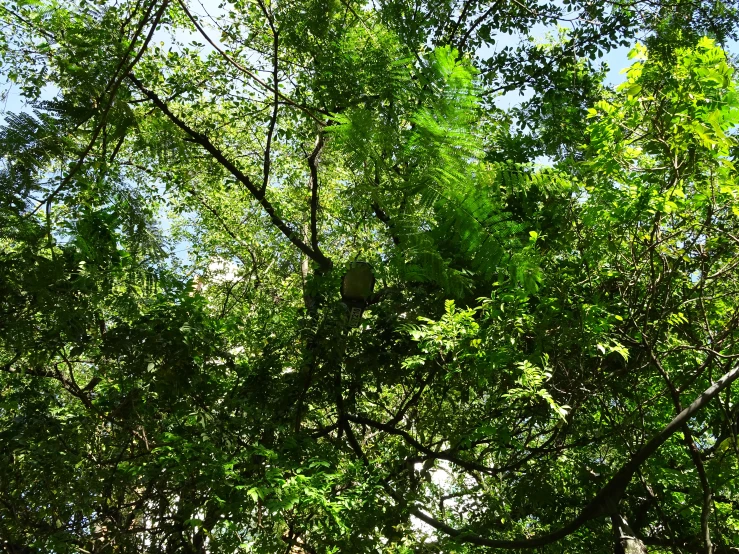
left=128, top=74, right=333, bottom=270
